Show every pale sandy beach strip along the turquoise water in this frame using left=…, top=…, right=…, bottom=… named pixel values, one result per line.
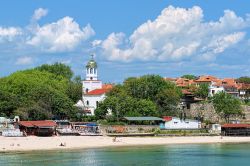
left=0, top=136, right=250, bottom=152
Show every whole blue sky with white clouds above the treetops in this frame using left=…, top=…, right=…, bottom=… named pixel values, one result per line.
left=0, top=0, right=250, bottom=82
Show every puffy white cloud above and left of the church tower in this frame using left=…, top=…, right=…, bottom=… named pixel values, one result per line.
left=27, top=16, right=95, bottom=52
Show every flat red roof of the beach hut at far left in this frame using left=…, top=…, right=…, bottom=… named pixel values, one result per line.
left=18, top=120, right=56, bottom=127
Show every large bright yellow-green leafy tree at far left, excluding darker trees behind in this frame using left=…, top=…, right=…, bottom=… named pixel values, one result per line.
left=0, top=69, right=76, bottom=119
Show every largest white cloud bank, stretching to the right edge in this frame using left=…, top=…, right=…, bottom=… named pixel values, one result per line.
left=101, top=6, right=250, bottom=61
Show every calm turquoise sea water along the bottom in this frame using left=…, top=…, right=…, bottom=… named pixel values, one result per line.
left=0, top=144, right=250, bottom=166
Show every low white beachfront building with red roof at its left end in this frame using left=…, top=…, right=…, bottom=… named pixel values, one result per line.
left=160, top=116, right=201, bottom=129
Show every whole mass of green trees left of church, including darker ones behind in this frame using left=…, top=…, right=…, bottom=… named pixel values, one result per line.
left=0, top=63, right=81, bottom=120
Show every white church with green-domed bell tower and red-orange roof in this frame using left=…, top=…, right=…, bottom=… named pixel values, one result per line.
left=75, top=55, right=113, bottom=115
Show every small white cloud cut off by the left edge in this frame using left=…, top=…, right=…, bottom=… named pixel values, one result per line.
left=0, top=27, right=22, bottom=42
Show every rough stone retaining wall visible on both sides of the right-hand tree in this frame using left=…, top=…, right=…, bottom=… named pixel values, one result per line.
left=188, top=103, right=250, bottom=123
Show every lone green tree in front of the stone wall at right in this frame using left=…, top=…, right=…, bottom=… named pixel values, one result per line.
left=212, top=92, right=242, bottom=122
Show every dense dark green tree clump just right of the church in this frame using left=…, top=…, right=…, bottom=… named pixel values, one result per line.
left=95, top=75, right=181, bottom=121
